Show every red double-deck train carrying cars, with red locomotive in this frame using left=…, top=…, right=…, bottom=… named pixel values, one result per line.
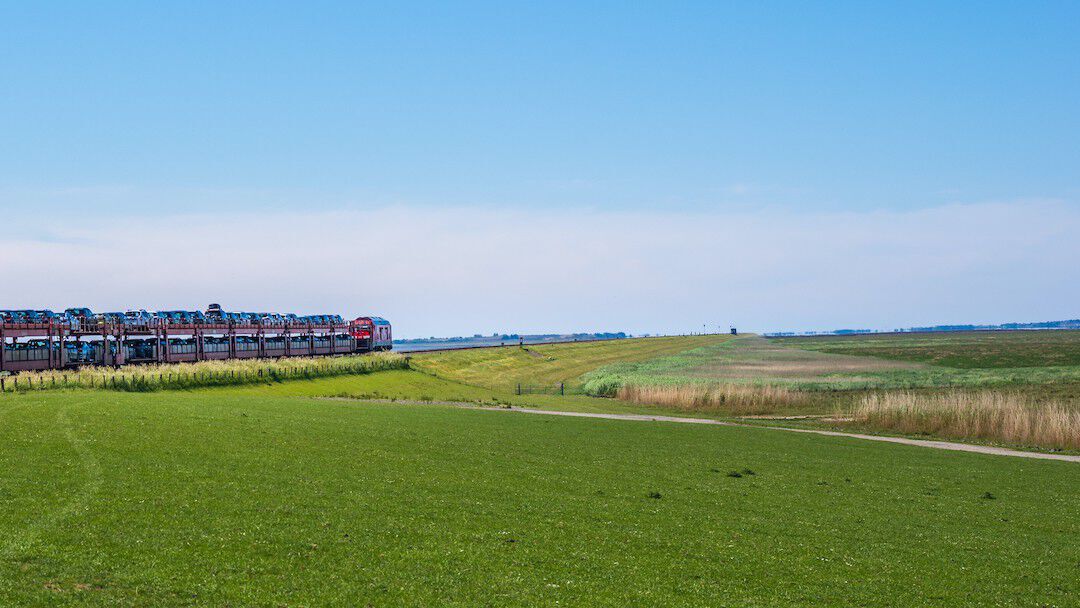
left=0, top=305, right=393, bottom=373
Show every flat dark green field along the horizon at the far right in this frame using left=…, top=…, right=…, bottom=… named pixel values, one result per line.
left=772, top=329, right=1080, bottom=369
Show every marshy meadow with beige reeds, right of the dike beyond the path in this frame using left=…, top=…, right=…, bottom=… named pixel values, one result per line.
left=582, top=332, right=1080, bottom=450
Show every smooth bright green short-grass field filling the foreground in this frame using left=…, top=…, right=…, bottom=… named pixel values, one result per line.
left=0, top=390, right=1080, bottom=606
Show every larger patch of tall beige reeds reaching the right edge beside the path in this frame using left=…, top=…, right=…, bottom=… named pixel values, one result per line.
left=850, top=391, right=1080, bottom=449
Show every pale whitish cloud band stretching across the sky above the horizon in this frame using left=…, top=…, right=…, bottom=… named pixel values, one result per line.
left=0, top=201, right=1080, bottom=336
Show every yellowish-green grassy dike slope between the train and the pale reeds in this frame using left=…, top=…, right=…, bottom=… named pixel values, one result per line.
left=410, top=335, right=731, bottom=391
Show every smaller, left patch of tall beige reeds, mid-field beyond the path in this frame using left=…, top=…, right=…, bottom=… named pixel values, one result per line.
left=616, top=383, right=807, bottom=416
